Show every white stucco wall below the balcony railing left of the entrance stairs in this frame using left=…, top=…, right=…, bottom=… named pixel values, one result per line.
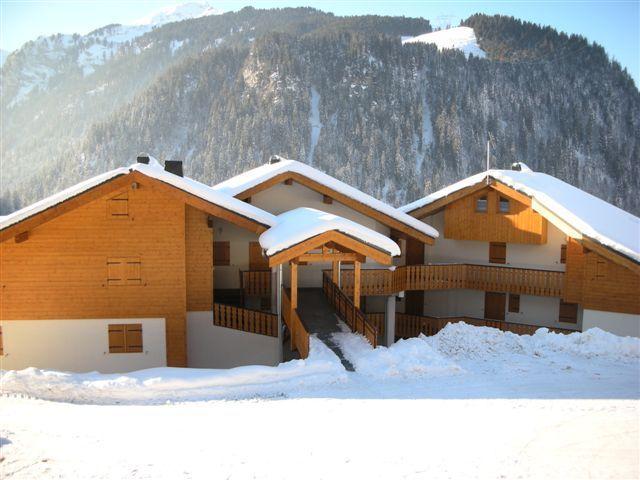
left=187, top=312, right=280, bottom=368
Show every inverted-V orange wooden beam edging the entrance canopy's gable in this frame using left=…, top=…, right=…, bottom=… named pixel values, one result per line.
left=269, top=230, right=392, bottom=267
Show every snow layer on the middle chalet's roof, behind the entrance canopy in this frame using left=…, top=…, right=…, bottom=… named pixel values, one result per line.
left=212, top=159, right=438, bottom=238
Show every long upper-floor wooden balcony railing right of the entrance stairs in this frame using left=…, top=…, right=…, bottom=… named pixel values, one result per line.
left=340, top=263, right=564, bottom=297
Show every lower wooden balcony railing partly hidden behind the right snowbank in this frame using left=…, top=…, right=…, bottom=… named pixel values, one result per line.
left=396, top=313, right=574, bottom=338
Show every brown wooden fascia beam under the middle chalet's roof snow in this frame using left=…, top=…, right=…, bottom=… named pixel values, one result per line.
left=236, top=172, right=435, bottom=245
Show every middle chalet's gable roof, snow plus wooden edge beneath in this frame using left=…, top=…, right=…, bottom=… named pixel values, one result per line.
left=213, top=159, right=438, bottom=243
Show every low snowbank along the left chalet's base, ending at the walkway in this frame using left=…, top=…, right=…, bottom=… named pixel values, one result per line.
left=0, top=337, right=347, bottom=404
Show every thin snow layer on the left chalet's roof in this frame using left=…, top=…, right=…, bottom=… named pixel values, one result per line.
left=0, top=158, right=276, bottom=230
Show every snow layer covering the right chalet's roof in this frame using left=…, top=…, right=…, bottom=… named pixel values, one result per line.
left=400, top=164, right=640, bottom=262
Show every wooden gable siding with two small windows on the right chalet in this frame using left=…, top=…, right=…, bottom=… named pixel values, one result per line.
left=444, top=186, right=547, bottom=245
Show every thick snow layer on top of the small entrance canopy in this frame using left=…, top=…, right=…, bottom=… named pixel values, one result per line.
left=259, top=207, right=400, bottom=257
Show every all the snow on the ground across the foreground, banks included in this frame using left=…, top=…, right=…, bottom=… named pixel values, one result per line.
left=0, top=324, right=640, bottom=480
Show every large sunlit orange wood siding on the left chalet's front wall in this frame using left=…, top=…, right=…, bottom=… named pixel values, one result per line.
left=0, top=181, right=187, bottom=366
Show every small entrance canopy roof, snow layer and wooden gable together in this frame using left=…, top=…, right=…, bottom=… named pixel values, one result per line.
left=260, top=208, right=400, bottom=267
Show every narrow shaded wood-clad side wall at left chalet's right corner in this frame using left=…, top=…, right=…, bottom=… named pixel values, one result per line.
left=185, top=205, right=214, bottom=312
